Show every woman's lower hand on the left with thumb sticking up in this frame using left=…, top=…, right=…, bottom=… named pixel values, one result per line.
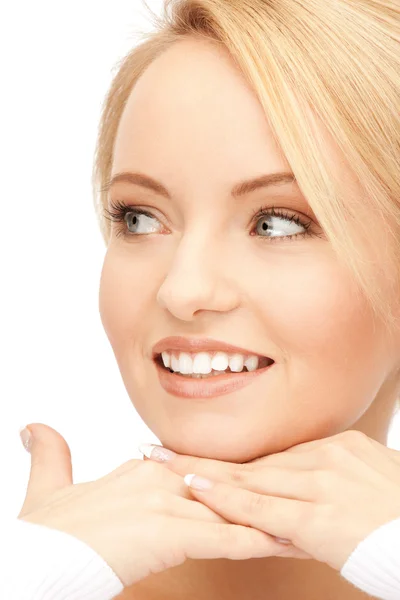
left=18, top=423, right=292, bottom=587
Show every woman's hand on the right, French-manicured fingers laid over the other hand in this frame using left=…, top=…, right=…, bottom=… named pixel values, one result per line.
left=141, top=430, right=400, bottom=571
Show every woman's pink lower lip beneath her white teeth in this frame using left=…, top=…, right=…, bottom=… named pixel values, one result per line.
left=155, top=361, right=275, bottom=398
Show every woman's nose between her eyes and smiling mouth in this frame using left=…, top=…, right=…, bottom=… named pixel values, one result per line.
left=157, top=235, right=239, bottom=321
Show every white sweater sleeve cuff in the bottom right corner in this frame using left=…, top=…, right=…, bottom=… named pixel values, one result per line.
left=340, top=518, right=400, bottom=600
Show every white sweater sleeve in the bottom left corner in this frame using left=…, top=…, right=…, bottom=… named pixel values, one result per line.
left=0, top=519, right=124, bottom=600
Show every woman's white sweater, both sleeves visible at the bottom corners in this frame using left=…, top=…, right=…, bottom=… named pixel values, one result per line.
left=0, top=518, right=400, bottom=600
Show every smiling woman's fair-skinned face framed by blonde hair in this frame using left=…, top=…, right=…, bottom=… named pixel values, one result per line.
left=100, top=40, right=398, bottom=462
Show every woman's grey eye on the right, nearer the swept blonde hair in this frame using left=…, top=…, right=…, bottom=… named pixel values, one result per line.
left=252, top=207, right=312, bottom=241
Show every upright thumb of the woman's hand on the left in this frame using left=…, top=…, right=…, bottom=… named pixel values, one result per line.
left=19, top=423, right=73, bottom=516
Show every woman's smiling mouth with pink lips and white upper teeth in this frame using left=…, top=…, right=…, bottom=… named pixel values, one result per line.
left=153, top=337, right=274, bottom=398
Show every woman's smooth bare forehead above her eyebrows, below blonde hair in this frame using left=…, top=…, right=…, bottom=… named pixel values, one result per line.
left=113, top=40, right=290, bottom=176
